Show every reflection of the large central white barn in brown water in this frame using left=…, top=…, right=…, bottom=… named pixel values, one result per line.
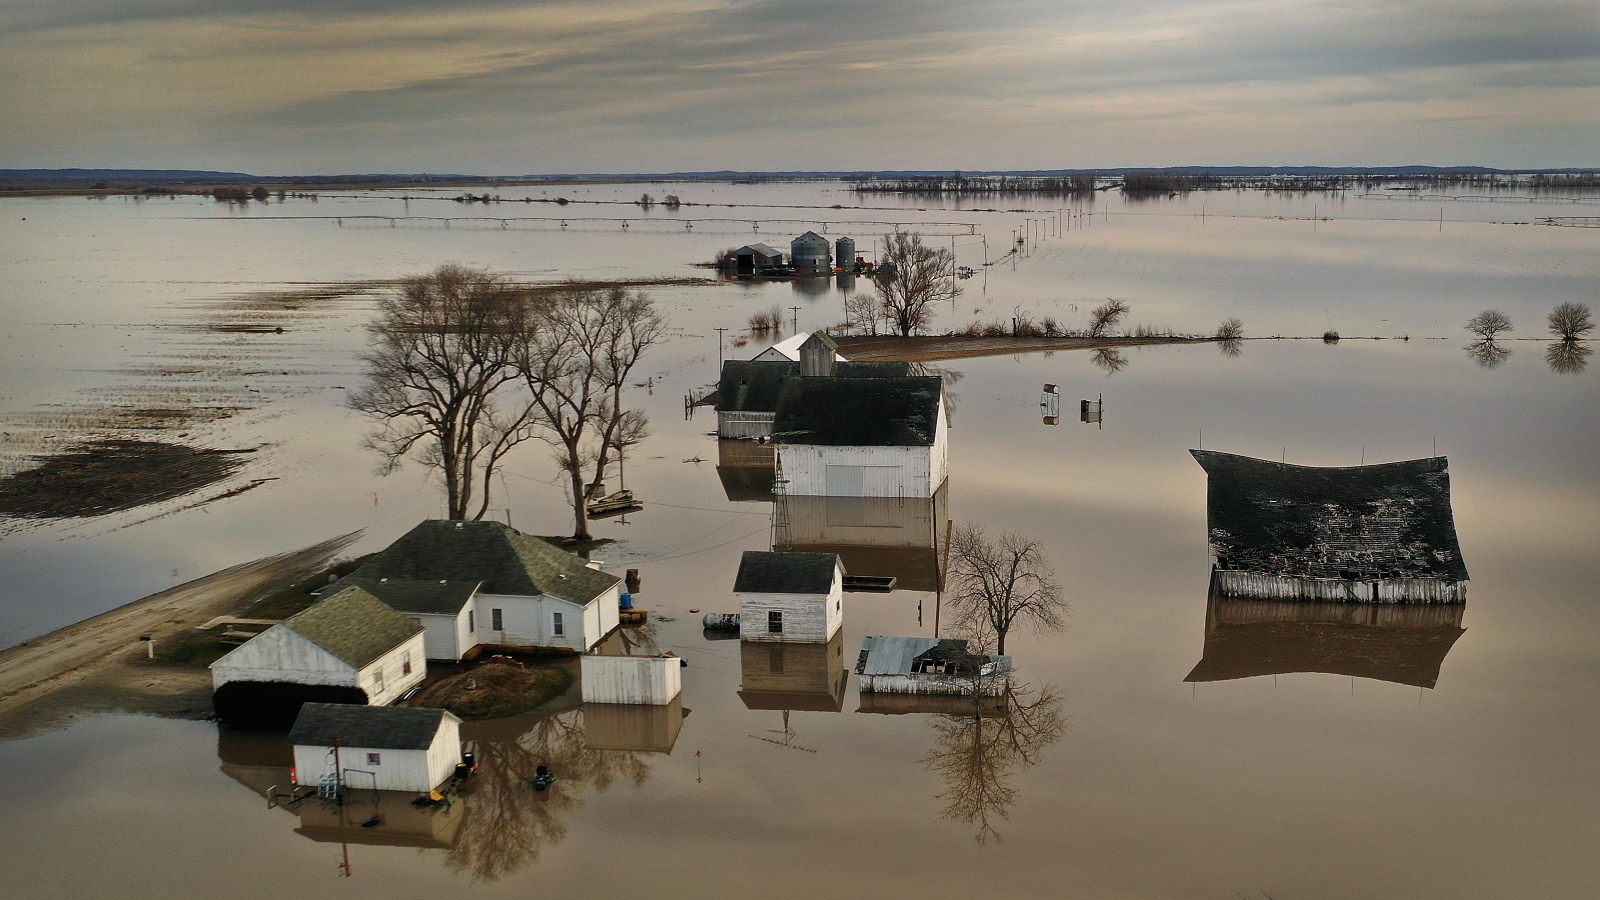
left=773, top=482, right=950, bottom=593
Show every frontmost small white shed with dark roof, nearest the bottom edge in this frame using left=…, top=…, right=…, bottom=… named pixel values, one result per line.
left=288, top=703, right=461, bottom=791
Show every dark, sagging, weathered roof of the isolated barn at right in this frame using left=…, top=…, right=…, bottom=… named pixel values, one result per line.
left=1190, top=450, right=1467, bottom=581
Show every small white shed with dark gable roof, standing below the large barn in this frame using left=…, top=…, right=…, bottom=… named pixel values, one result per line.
left=733, top=551, right=845, bottom=644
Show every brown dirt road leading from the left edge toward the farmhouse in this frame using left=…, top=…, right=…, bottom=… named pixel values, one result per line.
left=0, top=532, right=360, bottom=735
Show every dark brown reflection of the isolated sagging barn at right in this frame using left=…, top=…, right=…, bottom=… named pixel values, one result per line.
left=1184, top=596, right=1466, bottom=689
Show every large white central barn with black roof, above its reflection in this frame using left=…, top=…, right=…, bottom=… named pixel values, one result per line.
left=773, top=364, right=949, bottom=498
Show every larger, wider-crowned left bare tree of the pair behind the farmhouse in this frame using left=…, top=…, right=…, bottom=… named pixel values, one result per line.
left=347, top=266, right=536, bottom=519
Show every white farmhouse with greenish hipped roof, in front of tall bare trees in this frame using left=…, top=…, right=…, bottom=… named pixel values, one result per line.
left=347, top=519, right=622, bottom=660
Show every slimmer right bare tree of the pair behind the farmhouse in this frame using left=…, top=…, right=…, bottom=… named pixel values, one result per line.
left=518, top=288, right=666, bottom=540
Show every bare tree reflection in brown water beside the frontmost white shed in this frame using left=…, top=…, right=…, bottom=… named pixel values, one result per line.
left=445, top=709, right=650, bottom=881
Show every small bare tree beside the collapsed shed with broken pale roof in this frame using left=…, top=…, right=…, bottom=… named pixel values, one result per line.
left=946, top=522, right=1069, bottom=653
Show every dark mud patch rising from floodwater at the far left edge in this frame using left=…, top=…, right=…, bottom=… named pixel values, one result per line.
left=0, top=440, right=254, bottom=519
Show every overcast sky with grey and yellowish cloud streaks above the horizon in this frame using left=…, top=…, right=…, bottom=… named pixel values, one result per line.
left=0, top=0, right=1600, bottom=175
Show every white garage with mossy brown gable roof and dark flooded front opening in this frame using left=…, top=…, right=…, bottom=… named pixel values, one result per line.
left=211, top=586, right=427, bottom=706
